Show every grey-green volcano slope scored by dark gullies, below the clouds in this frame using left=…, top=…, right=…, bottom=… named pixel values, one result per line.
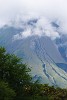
left=0, top=26, right=67, bottom=88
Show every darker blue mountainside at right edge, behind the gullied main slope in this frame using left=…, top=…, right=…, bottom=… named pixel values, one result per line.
left=54, top=34, right=67, bottom=72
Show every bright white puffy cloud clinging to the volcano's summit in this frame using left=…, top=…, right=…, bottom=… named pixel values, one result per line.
left=13, top=17, right=60, bottom=40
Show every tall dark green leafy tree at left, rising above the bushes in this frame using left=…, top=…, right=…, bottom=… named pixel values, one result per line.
left=0, top=47, right=31, bottom=97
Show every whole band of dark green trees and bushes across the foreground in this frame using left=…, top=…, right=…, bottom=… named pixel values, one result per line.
left=0, top=47, right=67, bottom=100
